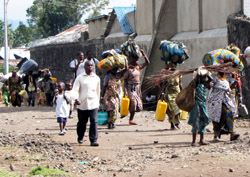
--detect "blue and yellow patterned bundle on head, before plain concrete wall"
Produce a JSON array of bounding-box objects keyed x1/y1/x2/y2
[{"x1": 160, "y1": 40, "x2": 189, "y2": 64}]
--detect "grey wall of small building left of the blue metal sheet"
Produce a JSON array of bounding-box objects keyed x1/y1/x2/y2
[{"x1": 88, "y1": 17, "x2": 108, "y2": 39}]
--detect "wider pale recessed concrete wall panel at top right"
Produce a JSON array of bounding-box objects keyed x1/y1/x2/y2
[{"x1": 202, "y1": 0, "x2": 241, "y2": 30}]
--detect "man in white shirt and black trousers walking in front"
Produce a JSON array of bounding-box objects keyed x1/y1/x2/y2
[{"x1": 73, "y1": 61, "x2": 100, "y2": 146}]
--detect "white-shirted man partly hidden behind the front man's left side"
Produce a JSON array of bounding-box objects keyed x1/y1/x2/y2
[{"x1": 69, "y1": 52, "x2": 85, "y2": 78}]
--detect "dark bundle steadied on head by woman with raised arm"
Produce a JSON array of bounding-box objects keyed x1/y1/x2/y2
[{"x1": 121, "y1": 40, "x2": 142, "y2": 60}]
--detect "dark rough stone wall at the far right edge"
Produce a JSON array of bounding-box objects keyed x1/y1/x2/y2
[{"x1": 228, "y1": 15, "x2": 250, "y2": 110}]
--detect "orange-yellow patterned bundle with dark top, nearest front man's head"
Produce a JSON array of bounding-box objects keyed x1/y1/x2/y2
[{"x1": 97, "y1": 50, "x2": 127, "y2": 71}]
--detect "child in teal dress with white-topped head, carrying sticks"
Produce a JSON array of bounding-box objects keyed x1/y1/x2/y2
[{"x1": 188, "y1": 68, "x2": 212, "y2": 146}]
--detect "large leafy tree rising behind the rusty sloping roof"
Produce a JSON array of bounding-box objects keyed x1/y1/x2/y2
[{"x1": 27, "y1": 0, "x2": 109, "y2": 39}]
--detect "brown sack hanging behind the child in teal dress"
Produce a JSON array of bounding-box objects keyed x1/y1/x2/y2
[{"x1": 175, "y1": 79, "x2": 195, "y2": 112}]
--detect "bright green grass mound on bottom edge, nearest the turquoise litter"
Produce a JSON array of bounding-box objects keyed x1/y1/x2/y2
[{"x1": 28, "y1": 166, "x2": 70, "y2": 177}]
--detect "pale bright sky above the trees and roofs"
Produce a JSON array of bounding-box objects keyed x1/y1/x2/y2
[{"x1": 0, "y1": 0, "x2": 136, "y2": 21}]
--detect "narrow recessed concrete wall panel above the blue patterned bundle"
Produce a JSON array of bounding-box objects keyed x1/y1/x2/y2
[{"x1": 177, "y1": 0, "x2": 199, "y2": 32}]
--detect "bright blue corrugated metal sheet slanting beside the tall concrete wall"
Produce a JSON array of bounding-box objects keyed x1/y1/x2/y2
[{"x1": 114, "y1": 7, "x2": 136, "y2": 34}]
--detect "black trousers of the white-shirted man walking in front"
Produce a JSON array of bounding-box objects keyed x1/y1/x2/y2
[{"x1": 76, "y1": 108, "x2": 98, "y2": 143}]
